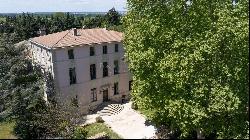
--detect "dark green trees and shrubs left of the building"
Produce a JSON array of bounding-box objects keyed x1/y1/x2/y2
[{"x1": 0, "y1": 35, "x2": 86, "y2": 139}]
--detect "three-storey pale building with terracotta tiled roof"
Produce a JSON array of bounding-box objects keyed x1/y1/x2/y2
[{"x1": 30, "y1": 28, "x2": 132, "y2": 112}]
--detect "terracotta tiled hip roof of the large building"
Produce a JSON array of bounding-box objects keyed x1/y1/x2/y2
[{"x1": 31, "y1": 28, "x2": 122, "y2": 48}]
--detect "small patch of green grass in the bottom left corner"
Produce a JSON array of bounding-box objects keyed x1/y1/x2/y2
[{"x1": 0, "y1": 122, "x2": 16, "y2": 139}]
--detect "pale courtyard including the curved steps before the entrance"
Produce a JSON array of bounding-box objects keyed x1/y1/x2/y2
[{"x1": 83, "y1": 102, "x2": 156, "y2": 139}]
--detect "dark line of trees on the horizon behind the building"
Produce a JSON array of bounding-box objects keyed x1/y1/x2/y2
[{"x1": 0, "y1": 8, "x2": 122, "y2": 42}]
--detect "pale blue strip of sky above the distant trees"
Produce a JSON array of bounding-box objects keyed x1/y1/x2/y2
[{"x1": 0, "y1": 0, "x2": 126, "y2": 13}]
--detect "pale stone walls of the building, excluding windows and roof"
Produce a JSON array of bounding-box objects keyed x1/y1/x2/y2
[{"x1": 31, "y1": 43, "x2": 132, "y2": 112}]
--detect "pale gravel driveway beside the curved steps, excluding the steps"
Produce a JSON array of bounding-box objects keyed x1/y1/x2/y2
[{"x1": 102, "y1": 102, "x2": 156, "y2": 139}]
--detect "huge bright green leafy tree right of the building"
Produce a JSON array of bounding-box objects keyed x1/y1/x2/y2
[{"x1": 123, "y1": 0, "x2": 249, "y2": 138}]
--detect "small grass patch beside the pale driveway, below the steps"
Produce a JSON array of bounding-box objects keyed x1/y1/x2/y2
[{"x1": 84, "y1": 123, "x2": 121, "y2": 139}]
